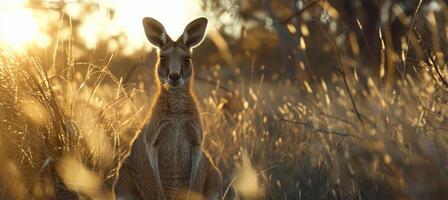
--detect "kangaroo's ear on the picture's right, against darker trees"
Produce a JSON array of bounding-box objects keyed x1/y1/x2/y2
[{"x1": 179, "y1": 17, "x2": 208, "y2": 48}]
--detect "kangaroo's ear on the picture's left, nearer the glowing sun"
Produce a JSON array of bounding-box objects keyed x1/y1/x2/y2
[{"x1": 143, "y1": 17, "x2": 171, "y2": 48}]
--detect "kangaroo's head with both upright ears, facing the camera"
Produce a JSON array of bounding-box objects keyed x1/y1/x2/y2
[{"x1": 143, "y1": 17, "x2": 207, "y2": 87}]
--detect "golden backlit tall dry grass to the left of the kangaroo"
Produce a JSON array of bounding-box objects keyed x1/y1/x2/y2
[{"x1": 0, "y1": 47, "x2": 142, "y2": 199}]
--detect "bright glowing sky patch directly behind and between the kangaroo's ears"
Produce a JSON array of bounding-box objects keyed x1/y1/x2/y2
[{"x1": 79, "y1": 0, "x2": 200, "y2": 54}]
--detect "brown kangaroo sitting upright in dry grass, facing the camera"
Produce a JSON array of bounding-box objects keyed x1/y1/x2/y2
[{"x1": 114, "y1": 17, "x2": 222, "y2": 200}]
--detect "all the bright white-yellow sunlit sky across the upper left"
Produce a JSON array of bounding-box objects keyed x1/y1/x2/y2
[{"x1": 0, "y1": 0, "x2": 201, "y2": 54}]
